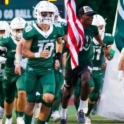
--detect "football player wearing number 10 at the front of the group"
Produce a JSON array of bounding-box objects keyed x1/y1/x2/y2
[{"x1": 21, "y1": 1, "x2": 64, "y2": 124}]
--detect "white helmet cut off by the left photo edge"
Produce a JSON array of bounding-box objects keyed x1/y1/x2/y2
[{"x1": 0, "y1": 21, "x2": 10, "y2": 36}]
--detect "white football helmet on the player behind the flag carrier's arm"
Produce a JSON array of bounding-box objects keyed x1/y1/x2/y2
[{"x1": 92, "y1": 14, "x2": 106, "y2": 36}]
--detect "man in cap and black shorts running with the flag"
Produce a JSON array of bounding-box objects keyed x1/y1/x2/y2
[{"x1": 60, "y1": 6, "x2": 110, "y2": 124}]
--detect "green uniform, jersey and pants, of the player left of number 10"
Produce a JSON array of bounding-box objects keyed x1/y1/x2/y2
[{"x1": 0, "y1": 35, "x2": 25, "y2": 103}]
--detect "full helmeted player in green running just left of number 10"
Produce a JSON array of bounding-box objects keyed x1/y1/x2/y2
[{"x1": 0, "y1": 17, "x2": 26, "y2": 124}]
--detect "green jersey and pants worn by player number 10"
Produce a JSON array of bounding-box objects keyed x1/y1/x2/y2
[{"x1": 23, "y1": 24, "x2": 64, "y2": 102}]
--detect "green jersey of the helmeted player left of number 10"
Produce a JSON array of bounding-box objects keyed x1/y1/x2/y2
[{"x1": 0, "y1": 35, "x2": 18, "y2": 70}]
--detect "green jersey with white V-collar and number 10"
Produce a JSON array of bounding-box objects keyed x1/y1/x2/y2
[{"x1": 23, "y1": 23, "x2": 64, "y2": 68}]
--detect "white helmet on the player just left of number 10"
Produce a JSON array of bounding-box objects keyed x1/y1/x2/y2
[{"x1": 10, "y1": 17, "x2": 26, "y2": 41}]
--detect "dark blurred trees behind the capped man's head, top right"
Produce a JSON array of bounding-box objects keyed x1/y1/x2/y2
[{"x1": 76, "y1": 0, "x2": 118, "y2": 33}]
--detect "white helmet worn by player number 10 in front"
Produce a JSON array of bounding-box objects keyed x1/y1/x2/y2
[{"x1": 34, "y1": 1, "x2": 55, "y2": 25}]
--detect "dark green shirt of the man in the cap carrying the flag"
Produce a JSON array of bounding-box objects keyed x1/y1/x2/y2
[{"x1": 66, "y1": 25, "x2": 98, "y2": 69}]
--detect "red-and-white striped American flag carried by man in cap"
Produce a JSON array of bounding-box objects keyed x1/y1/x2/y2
[{"x1": 64, "y1": 0, "x2": 84, "y2": 69}]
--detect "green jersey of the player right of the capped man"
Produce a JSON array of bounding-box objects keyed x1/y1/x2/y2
[{"x1": 93, "y1": 33, "x2": 114, "y2": 68}]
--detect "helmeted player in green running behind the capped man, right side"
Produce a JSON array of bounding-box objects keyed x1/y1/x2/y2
[{"x1": 85, "y1": 15, "x2": 114, "y2": 124}]
